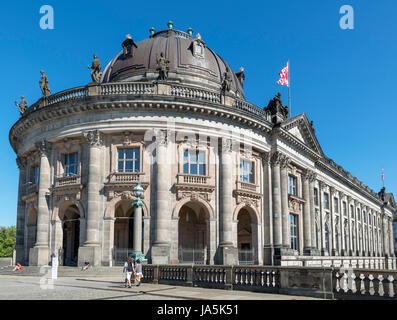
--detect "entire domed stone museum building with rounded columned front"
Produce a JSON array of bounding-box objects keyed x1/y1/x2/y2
[{"x1": 9, "y1": 22, "x2": 397, "y2": 269}]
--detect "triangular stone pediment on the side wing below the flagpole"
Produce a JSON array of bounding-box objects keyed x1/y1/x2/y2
[{"x1": 281, "y1": 113, "x2": 324, "y2": 156}]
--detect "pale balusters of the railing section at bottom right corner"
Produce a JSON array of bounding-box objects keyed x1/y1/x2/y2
[{"x1": 332, "y1": 268, "x2": 397, "y2": 299}]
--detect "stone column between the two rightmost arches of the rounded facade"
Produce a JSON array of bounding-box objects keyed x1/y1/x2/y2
[{"x1": 215, "y1": 139, "x2": 238, "y2": 265}]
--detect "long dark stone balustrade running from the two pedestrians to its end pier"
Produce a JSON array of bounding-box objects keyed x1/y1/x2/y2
[{"x1": 143, "y1": 265, "x2": 333, "y2": 299}]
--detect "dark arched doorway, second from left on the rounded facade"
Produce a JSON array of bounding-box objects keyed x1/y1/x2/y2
[{"x1": 61, "y1": 205, "x2": 80, "y2": 266}]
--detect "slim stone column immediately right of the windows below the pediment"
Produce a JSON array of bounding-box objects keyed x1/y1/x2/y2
[{"x1": 302, "y1": 170, "x2": 312, "y2": 255}]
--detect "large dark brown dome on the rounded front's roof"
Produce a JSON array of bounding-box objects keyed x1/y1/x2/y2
[{"x1": 101, "y1": 29, "x2": 245, "y2": 99}]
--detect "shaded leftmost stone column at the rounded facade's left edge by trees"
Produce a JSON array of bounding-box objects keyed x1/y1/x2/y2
[{"x1": 15, "y1": 157, "x2": 28, "y2": 264}]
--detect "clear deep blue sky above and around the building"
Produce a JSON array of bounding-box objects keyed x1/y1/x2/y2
[{"x1": 0, "y1": 0, "x2": 397, "y2": 226}]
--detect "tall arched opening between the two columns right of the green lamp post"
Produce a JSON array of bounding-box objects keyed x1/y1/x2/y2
[{"x1": 178, "y1": 201, "x2": 208, "y2": 264}]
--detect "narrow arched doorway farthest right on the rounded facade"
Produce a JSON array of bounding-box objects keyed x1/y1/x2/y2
[{"x1": 237, "y1": 208, "x2": 255, "y2": 264}]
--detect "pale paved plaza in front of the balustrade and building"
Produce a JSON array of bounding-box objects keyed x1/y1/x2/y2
[{"x1": 0, "y1": 275, "x2": 317, "y2": 300}]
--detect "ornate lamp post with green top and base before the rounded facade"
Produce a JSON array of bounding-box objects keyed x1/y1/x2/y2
[{"x1": 131, "y1": 181, "x2": 147, "y2": 262}]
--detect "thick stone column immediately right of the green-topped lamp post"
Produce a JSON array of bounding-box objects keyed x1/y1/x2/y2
[{"x1": 151, "y1": 131, "x2": 171, "y2": 264}]
